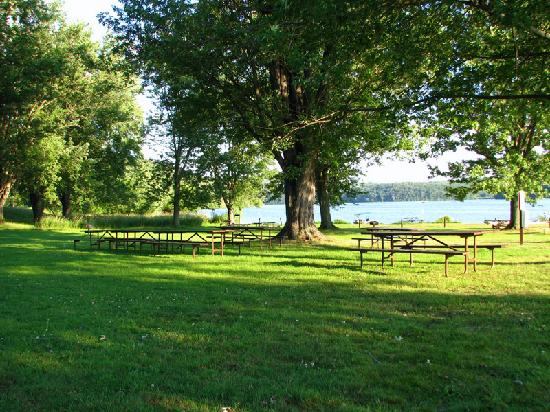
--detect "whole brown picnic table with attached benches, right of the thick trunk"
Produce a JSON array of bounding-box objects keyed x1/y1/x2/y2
[{"x1": 354, "y1": 228, "x2": 500, "y2": 275}]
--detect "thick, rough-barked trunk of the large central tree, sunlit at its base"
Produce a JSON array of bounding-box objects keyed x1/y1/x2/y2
[{"x1": 281, "y1": 158, "x2": 323, "y2": 240}]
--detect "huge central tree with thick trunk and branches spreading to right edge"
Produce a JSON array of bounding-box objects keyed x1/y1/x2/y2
[{"x1": 105, "y1": 0, "x2": 548, "y2": 238}]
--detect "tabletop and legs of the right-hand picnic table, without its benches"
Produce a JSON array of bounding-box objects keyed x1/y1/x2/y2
[{"x1": 365, "y1": 229, "x2": 485, "y2": 273}]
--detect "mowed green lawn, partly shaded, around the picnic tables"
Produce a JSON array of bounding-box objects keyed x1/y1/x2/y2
[{"x1": 0, "y1": 224, "x2": 550, "y2": 411}]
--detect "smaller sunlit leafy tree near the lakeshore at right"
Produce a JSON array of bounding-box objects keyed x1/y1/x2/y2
[{"x1": 433, "y1": 102, "x2": 550, "y2": 227}]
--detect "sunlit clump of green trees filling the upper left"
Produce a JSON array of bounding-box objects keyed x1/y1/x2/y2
[{"x1": 0, "y1": 0, "x2": 147, "y2": 221}]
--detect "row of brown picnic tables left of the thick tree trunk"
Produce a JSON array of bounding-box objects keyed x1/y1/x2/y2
[{"x1": 84, "y1": 224, "x2": 282, "y2": 256}]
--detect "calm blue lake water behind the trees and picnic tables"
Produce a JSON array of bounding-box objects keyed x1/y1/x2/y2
[{"x1": 202, "y1": 199, "x2": 550, "y2": 223}]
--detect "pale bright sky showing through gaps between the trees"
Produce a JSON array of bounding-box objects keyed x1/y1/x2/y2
[{"x1": 49, "y1": 0, "x2": 469, "y2": 183}]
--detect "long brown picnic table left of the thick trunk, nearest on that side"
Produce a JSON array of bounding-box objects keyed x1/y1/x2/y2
[{"x1": 84, "y1": 229, "x2": 232, "y2": 256}]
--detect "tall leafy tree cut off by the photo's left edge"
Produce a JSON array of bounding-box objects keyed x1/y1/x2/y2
[{"x1": 0, "y1": 0, "x2": 62, "y2": 223}]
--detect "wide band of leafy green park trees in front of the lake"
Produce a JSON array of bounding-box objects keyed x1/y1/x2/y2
[{"x1": 0, "y1": 0, "x2": 550, "y2": 235}]
